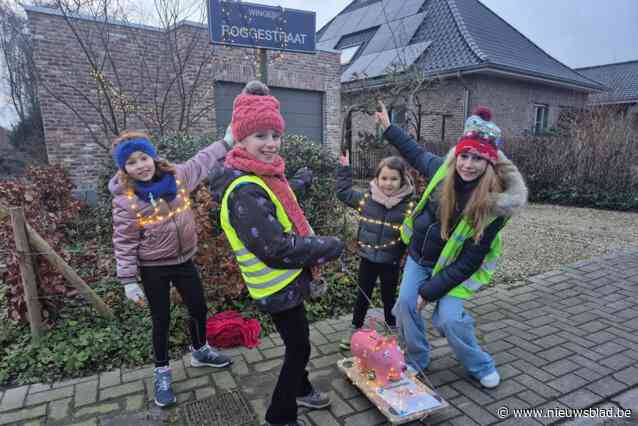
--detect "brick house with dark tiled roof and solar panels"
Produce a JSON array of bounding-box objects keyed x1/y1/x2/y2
[{"x1": 318, "y1": 0, "x2": 604, "y2": 152}]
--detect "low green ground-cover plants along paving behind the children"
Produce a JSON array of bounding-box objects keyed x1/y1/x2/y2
[{"x1": 0, "y1": 243, "x2": 372, "y2": 386}]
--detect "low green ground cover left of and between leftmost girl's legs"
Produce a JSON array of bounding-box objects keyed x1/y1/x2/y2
[{"x1": 0, "y1": 279, "x2": 190, "y2": 385}]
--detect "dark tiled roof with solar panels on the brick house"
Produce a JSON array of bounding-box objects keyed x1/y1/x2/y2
[{"x1": 318, "y1": 0, "x2": 603, "y2": 90}]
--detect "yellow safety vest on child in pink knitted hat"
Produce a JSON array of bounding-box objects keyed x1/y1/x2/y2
[{"x1": 220, "y1": 175, "x2": 302, "y2": 299}]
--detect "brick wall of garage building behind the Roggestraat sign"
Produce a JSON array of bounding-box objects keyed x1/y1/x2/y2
[{"x1": 27, "y1": 9, "x2": 341, "y2": 197}]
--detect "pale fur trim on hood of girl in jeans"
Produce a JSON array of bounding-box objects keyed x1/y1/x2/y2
[{"x1": 445, "y1": 148, "x2": 528, "y2": 217}]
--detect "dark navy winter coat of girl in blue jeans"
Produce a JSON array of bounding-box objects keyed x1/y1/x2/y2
[{"x1": 384, "y1": 125, "x2": 527, "y2": 301}]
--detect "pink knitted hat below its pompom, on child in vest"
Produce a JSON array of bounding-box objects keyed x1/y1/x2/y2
[{"x1": 232, "y1": 93, "x2": 285, "y2": 141}]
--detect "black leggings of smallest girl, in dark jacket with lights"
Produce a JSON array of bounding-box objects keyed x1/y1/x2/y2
[{"x1": 352, "y1": 258, "x2": 399, "y2": 328}]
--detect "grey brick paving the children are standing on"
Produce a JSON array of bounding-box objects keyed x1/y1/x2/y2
[{"x1": 0, "y1": 250, "x2": 638, "y2": 426}]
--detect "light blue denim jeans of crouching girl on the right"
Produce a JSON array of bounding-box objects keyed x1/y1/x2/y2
[{"x1": 393, "y1": 256, "x2": 496, "y2": 379}]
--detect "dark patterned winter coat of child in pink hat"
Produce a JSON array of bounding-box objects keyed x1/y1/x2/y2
[{"x1": 209, "y1": 168, "x2": 344, "y2": 312}]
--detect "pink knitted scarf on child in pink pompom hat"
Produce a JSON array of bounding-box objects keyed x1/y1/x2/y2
[{"x1": 224, "y1": 147, "x2": 312, "y2": 237}]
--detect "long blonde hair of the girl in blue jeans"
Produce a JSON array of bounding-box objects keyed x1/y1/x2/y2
[{"x1": 439, "y1": 156, "x2": 503, "y2": 243}]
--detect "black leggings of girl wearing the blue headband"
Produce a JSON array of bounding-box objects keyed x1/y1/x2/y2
[{"x1": 140, "y1": 260, "x2": 208, "y2": 367}]
